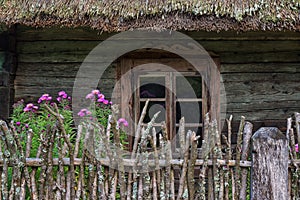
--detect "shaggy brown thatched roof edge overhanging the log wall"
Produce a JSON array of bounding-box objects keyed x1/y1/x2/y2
[{"x1": 0, "y1": 0, "x2": 300, "y2": 32}]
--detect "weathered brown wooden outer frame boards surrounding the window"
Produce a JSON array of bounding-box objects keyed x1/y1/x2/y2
[{"x1": 120, "y1": 58, "x2": 220, "y2": 147}]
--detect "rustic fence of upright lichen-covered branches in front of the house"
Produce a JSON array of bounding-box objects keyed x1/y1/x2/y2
[{"x1": 0, "y1": 103, "x2": 300, "y2": 200}]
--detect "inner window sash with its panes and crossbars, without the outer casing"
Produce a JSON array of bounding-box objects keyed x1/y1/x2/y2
[{"x1": 134, "y1": 71, "x2": 203, "y2": 147}]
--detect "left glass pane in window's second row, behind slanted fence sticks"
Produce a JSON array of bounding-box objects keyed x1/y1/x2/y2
[{"x1": 140, "y1": 101, "x2": 166, "y2": 123}]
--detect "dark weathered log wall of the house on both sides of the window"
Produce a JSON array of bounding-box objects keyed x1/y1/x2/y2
[{"x1": 14, "y1": 27, "x2": 300, "y2": 132}]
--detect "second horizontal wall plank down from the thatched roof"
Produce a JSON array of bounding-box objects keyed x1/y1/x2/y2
[{"x1": 17, "y1": 39, "x2": 300, "y2": 54}]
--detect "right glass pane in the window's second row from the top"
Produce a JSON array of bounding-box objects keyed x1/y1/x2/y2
[{"x1": 176, "y1": 102, "x2": 202, "y2": 123}]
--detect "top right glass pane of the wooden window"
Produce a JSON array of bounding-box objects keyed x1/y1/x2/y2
[{"x1": 176, "y1": 76, "x2": 202, "y2": 98}]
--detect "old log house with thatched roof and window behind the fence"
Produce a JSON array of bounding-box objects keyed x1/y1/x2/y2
[{"x1": 0, "y1": 0, "x2": 300, "y2": 139}]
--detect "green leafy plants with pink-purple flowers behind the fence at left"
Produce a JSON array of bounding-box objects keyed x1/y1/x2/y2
[{"x1": 11, "y1": 90, "x2": 128, "y2": 157}]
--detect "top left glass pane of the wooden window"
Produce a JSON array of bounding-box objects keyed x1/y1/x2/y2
[{"x1": 140, "y1": 76, "x2": 166, "y2": 98}]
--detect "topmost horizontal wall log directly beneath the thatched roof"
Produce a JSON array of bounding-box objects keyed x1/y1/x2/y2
[{"x1": 16, "y1": 26, "x2": 299, "y2": 41}]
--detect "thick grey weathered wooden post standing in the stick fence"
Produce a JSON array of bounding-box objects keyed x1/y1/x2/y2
[{"x1": 251, "y1": 127, "x2": 289, "y2": 200}]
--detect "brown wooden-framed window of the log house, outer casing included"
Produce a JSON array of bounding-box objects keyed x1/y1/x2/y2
[{"x1": 121, "y1": 58, "x2": 219, "y2": 147}]
